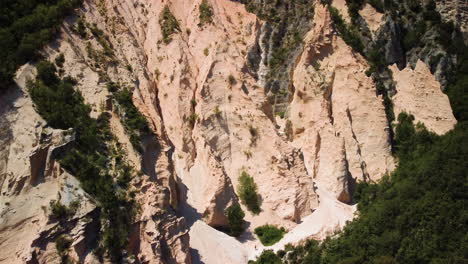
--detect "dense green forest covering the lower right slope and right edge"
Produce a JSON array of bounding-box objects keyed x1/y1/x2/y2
[{"x1": 252, "y1": 0, "x2": 468, "y2": 264}]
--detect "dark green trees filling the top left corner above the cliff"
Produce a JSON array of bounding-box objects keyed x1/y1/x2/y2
[{"x1": 0, "y1": 0, "x2": 82, "y2": 90}]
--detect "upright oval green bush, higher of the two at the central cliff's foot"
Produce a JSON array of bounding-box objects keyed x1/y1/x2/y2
[{"x1": 237, "y1": 171, "x2": 261, "y2": 214}]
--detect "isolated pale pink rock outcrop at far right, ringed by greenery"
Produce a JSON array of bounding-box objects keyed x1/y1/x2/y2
[{"x1": 389, "y1": 61, "x2": 457, "y2": 135}]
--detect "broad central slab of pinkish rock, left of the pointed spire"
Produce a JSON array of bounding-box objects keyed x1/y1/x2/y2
[{"x1": 152, "y1": 1, "x2": 317, "y2": 230}]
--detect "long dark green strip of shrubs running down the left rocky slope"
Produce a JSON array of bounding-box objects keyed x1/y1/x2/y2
[{"x1": 28, "y1": 61, "x2": 136, "y2": 262}]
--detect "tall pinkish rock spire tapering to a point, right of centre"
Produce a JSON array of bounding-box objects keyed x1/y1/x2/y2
[{"x1": 289, "y1": 5, "x2": 394, "y2": 202}]
